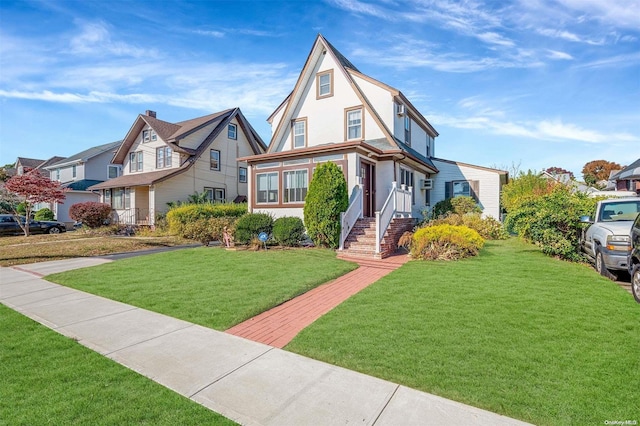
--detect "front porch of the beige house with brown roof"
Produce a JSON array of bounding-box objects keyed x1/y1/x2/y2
[{"x1": 104, "y1": 186, "x2": 155, "y2": 226}]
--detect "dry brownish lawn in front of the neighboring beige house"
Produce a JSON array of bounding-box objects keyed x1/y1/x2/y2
[{"x1": 0, "y1": 231, "x2": 193, "y2": 266}]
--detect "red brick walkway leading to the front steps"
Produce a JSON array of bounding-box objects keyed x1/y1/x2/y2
[{"x1": 226, "y1": 254, "x2": 409, "y2": 348}]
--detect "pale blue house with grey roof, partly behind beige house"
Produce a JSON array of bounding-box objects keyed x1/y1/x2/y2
[{"x1": 44, "y1": 141, "x2": 122, "y2": 224}]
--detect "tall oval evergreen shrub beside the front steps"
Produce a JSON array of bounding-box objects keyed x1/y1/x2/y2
[{"x1": 304, "y1": 161, "x2": 349, "y2": 248}]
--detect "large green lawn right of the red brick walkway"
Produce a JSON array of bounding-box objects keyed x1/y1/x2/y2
[{"x1": 286, "y1": 240, "x2": 640, "y2": 425}]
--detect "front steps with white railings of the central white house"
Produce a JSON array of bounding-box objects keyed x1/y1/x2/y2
[{"x1": 339, "y1": 178, "x2": 416, "y2": 259}]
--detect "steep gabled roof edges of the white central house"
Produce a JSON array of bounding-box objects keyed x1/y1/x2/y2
[{"x1": 267, "y1": 34, "x2": 438, "y2": 161}]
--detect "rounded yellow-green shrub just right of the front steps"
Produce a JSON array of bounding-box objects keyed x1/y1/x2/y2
[{"x1": 411, "y1": 224, "x2": 484, "y2": 260}]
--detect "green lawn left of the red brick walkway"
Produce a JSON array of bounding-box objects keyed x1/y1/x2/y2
[{"x1": 47, "y1": 247, "x2": 357, "y2": 330}]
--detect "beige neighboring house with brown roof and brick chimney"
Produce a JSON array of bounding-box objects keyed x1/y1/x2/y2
[{"x1": 89, "y1": 108, "x2": 266, "y2": 225}]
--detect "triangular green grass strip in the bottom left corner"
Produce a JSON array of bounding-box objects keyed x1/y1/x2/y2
[{"x1": 0, "y1": 305, "x2": 235, "y2": 426}]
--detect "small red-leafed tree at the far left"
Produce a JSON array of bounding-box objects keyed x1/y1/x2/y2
[{"x1": 4, "y1": 170, "x2": 66, "y2": 237}]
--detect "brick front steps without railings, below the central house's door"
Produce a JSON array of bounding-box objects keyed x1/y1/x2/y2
[{"x1": 339, "y1": 217, "x2": 416, "y2": 259}]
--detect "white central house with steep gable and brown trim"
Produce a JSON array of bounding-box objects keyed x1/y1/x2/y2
[{"x1": 241, "y1": 35, "x2": 508, "y2": 257}]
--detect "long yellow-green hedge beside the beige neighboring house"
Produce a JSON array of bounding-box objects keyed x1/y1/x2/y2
[{"x1": 166, "y1": 203, "x2": 247, "y2": 235}]
